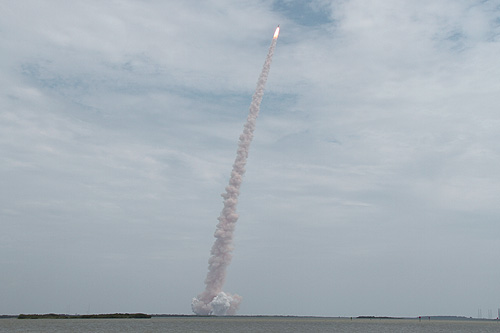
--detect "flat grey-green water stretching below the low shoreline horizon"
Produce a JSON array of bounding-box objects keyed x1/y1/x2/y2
[{"x1": 0, "y1": 317, "x2": 500, "y2": 333}]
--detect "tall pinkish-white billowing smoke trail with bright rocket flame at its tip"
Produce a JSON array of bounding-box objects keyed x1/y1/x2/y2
[{"x1": 191, "y1": 26, "x2": 280, "y2": 316}]
